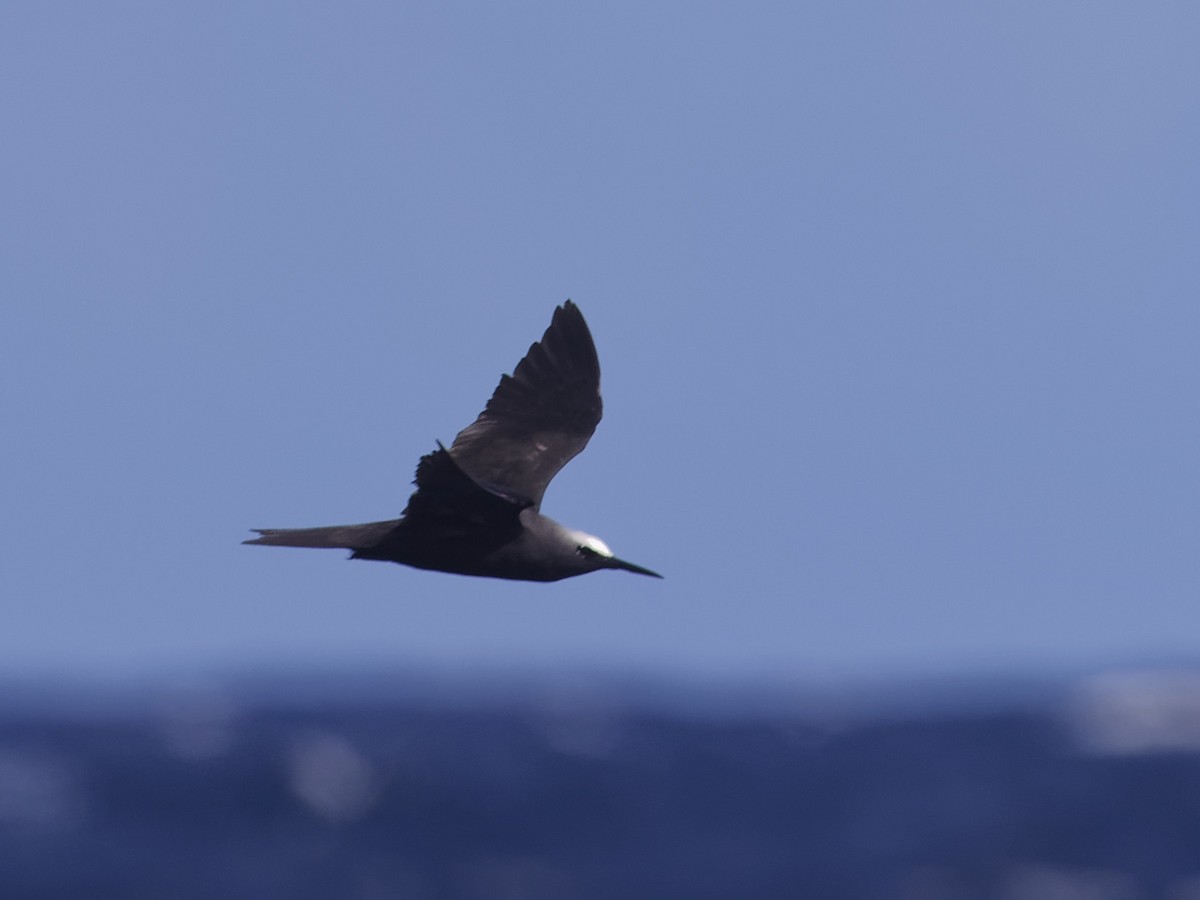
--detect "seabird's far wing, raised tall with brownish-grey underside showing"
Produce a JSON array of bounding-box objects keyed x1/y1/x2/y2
[{"x1": 450, "y1": 300, "x2": 602, "y2": 509}]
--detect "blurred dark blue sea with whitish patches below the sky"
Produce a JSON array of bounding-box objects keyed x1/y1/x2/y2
[{"x1": 0, "y1": 676, "x2": 1200, "y2": 900}]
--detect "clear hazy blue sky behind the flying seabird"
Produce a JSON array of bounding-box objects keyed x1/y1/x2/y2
[{"x1": 0, "y1": 1, "x2": 1200, "y2": 678}]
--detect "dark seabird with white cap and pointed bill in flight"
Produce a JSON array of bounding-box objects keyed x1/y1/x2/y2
[{"x1": 242, "y1": 300, "x2": 662, "y2": 582}]
